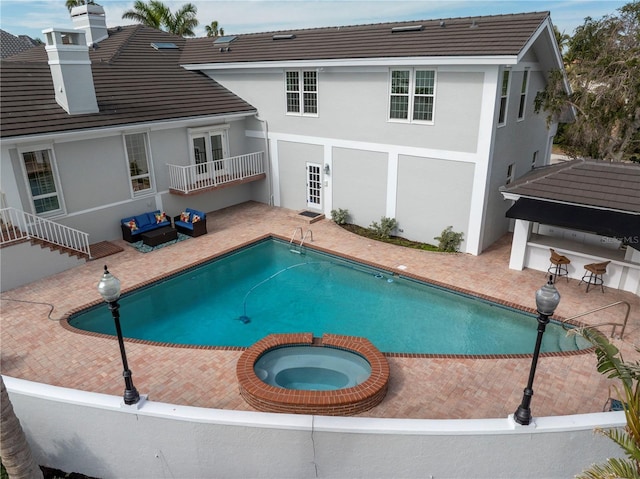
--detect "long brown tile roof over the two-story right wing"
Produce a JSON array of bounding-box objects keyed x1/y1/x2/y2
[{"x1": 180, "y1": 11, "x2": 549, "y2": 65}]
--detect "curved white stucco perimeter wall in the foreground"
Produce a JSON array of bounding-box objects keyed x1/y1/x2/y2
[{"x1": 3, "y1": 376, "x2": 625, "y2": 479}]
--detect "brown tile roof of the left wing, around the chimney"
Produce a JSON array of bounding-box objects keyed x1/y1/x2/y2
[{"x1": 0, "y1": 25, "x2": 256, "y2": 138}]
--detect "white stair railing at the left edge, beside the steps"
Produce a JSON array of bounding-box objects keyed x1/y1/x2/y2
[{"x1": 0, "y1": 208, "x2": 91, "y2": 258}]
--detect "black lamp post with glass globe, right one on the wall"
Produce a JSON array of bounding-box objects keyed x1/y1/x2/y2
[{"x1": 513, "y1": 276, "x2": 560, "y2": 426}]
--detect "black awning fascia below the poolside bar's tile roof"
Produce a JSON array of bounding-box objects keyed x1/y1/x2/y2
[{"x1": 506, "y1": 198, "x2": 640, "y2": 249}]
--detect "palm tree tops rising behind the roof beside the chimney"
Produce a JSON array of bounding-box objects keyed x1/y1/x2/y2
[{"x1": 122, "y1": 0, "x2": 198, "y2": 37}]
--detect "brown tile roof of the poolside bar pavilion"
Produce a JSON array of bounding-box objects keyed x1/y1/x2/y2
[{"x1": 502, "y1": 160, "x2": 640, "y2": 213}]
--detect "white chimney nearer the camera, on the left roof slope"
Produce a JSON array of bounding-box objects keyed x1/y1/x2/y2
[{"x1": 42, "y1": 28, "x2": 100, "y2": 115}]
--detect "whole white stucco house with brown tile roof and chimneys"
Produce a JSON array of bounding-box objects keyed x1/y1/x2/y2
[{"x1": 0, "y1": 5, "x2": 562, "y2": 289}]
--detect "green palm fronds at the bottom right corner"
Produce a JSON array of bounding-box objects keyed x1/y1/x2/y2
[{"x1": 576, "y1": 327, "x2": 640, "y2": 479}]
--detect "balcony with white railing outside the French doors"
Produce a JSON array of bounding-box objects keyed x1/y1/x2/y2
[{"x1": 167, "y1": 151, "x2": 266, "y2": 195}]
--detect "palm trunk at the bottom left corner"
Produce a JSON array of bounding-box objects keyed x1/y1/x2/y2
[{"x1": 0, "y1": 376, "x2": 43, "y2": 478}]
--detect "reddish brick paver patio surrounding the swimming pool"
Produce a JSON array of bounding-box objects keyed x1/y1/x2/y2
[{"x1": 0, "y1": 202, "x2": 640, "y2": 418}]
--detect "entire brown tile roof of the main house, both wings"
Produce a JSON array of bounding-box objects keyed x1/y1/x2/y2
[{"x1": 0, "y1": 12, "x2": 549, "y2": 138}]
